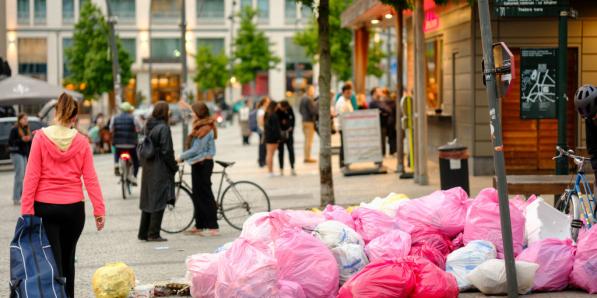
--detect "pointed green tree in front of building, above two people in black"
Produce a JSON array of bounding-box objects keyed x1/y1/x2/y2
[{"x1": 234, "y1": 7, "x2": 280, "y2": 95}]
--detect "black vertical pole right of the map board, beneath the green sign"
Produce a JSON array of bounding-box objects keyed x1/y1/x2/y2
[{"x1": 556, "y1": 9, "x2": 568, "y2": 175}]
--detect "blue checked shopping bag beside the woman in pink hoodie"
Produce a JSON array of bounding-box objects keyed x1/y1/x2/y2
[{"x1": 10, "y1": 215, "x2": 66, "y2": 298}]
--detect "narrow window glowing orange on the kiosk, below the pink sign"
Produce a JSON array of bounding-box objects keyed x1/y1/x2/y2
[{"x1": 425, "y1": 39, "x2": 443, "y2": 114}]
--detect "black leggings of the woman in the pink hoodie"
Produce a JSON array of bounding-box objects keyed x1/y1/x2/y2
[{"x1": 34, "y1": 202, "x2": 85, "y2": 298}]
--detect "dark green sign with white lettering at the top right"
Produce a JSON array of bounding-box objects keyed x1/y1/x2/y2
[{"x1": 494, "y1": 0, "x2": 568, "y2": 17}]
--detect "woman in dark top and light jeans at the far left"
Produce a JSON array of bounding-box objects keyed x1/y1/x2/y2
[{"x1": 8, "y1": 113, "x2": 33, "y2": 205}]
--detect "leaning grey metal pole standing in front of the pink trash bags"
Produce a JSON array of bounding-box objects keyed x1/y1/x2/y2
[{"x1": 478, "y1": 0, "x2": 518, "y2": 297}]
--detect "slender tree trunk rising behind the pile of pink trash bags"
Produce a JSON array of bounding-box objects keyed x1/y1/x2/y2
[{"x1": 317, "y1": 0, "x2": 334, "y2": 207}]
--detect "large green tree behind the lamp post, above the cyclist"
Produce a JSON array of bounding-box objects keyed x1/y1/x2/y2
[{"x1": 66, "y1": 1, "x2": 132, "y2": 98}]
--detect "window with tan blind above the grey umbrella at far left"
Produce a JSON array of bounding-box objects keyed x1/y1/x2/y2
[{"x1": 18, "y1": 38, "x2": 48, "y2": 81}]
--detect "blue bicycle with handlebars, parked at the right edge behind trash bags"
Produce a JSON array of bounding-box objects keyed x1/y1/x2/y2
[{"x1": 553, "y1": 146, "x2": 597, "y2": 241}]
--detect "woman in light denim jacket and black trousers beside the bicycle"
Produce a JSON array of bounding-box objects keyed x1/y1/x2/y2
[{"x1": 178, "y1": 102, "x2": 219, "y2": 236}]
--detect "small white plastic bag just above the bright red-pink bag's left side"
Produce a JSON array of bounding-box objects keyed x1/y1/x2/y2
[{"x1": 328, "y1": 244, "x2": 369, "y2": 284}]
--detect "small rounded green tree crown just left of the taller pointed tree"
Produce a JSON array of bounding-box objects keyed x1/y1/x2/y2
[{"x1": 194, "y1": 46, "x2": 229, "y2": 92}]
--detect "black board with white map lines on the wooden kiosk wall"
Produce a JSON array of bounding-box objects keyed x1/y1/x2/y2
[{"x1": 520, "y1": 48, "x2": 558, "y2": 119}]
